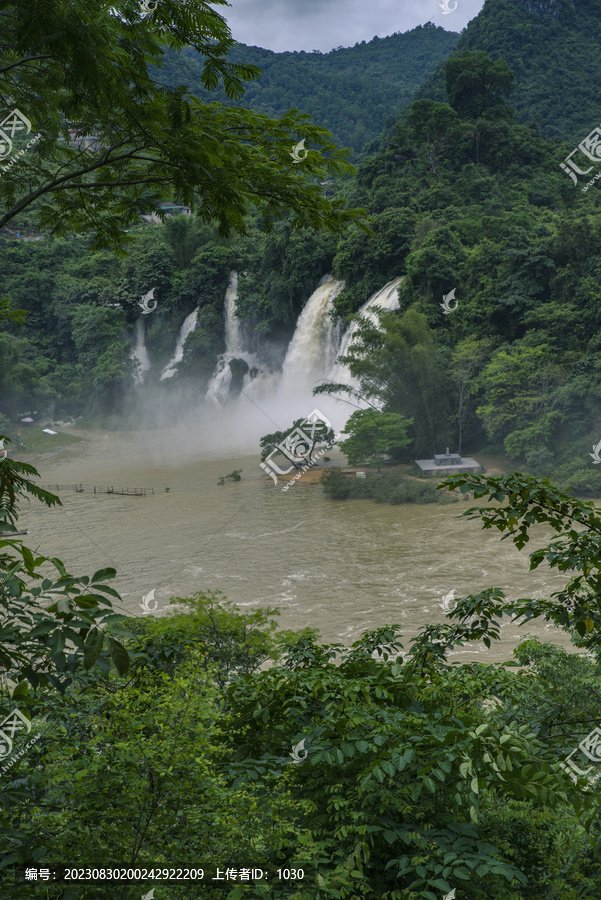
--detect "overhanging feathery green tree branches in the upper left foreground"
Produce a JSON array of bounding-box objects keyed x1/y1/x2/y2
[{"x1": 0, "y1": 0, "x2": 368, "y2": 247}]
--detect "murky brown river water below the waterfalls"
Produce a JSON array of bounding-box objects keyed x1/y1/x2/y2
[{"x1": 19, "y1": 431, "x2": 569, "y2": 662}]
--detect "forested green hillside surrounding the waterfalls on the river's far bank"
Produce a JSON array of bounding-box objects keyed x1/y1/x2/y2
[{"x1": 5, "y1": 0, "x2": 601, "y2": 495}]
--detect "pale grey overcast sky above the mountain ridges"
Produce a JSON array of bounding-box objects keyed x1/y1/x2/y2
[{"x1": 220, "y1": 0, "x2": 484, "y2": 53}]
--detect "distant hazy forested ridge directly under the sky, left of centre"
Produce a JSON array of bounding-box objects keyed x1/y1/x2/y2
[{"x1": 155, "y1": 22, "x2": 459, "y2": 152}]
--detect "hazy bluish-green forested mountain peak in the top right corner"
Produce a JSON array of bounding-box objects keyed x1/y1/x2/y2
[{"x1": 416, "y1": 0, "x2": 601, "y2": 144}]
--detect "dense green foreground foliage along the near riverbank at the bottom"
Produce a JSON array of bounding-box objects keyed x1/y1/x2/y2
[{"x1": 0, "y1": 475, "x2": 601, "y2": 900}]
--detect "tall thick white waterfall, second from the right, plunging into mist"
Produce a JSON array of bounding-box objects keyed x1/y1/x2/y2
[{"x1": 282, "y1": 275, "x2": 344, "y2": 391}]
